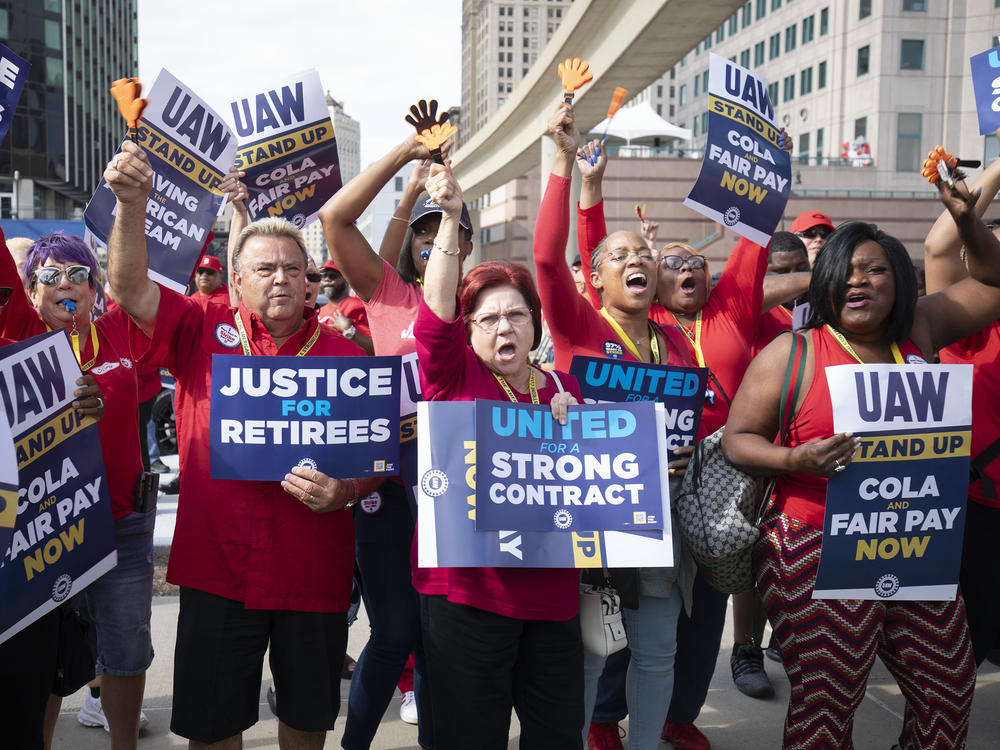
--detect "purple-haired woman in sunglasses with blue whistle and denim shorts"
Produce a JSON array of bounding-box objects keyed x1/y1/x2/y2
[{"x1": 0, "y1": 232, "x2": 156, "y2": 748}]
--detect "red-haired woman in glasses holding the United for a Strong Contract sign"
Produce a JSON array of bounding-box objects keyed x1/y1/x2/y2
[{"x1": 414, "y1": 167, "x2": 583, "y2": 750}]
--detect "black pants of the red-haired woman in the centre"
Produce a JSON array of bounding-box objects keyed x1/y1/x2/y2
[{"x1": 420, "y1": 596, "x2": 583, "y2": 750}]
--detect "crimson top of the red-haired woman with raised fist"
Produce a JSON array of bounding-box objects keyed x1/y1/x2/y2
[{"x1": 414, "y1": 303, "x2": 583, "y2": 620}]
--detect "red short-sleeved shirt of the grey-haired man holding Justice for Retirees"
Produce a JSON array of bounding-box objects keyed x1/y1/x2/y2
[{"x1": 130, "y1": 287, "x2": 364, "y2": 612}]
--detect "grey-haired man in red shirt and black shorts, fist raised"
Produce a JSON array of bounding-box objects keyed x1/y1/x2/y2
[{"x1": 104, "y1": 142, "x2": 379, "y2": 748}]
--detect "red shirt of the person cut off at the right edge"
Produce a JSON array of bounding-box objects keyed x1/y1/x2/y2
[{"x1": 938, "y1": 320, "x2": 1000, "y2": 508}]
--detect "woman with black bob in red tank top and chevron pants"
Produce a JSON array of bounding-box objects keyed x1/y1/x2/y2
[{"x1": 723, "y1": 183, "x2": 1000, "y2": 748}]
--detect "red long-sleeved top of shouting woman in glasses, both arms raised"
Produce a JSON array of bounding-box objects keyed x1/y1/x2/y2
[{"x1": 534, "y1": 174, "x2": 694, "y2": 371}]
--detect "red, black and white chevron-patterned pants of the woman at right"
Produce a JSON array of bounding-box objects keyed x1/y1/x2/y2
[{"x1": 754, "y1": 510, "x2": 976, "y2": 750}]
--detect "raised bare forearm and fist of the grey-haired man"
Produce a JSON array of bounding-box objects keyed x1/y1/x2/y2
[{"x1": 104, "y1": 141, "x2": 160, "y2": 336}]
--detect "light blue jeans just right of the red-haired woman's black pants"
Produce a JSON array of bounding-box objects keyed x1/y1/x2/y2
[{"x1": 583, "y1": 583, "x2": 683, "y2": 750}]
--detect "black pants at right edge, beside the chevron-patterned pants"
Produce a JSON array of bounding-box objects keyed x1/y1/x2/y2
[{"x1": 959, "y1": 499, "x2": 1000, "y2": 667}]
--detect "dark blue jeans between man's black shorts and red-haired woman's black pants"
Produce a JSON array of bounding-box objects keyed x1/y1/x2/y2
[{"x1": 341, "y1": 482, "x2": 433, "y2": 750}]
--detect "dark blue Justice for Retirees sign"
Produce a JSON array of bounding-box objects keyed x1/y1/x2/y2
[{"x1": 210, "y1": 354, "x2": 400, "y2": 481}]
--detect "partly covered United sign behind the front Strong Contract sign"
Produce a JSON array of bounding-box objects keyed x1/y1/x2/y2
[{"x1": 569, "y1": 355, "x2": 708, "y2": 455}]
